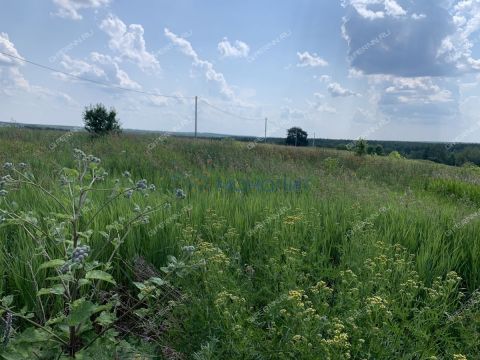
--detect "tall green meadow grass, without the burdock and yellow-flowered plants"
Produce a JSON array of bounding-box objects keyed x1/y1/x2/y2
[{"x1": 0, "y1": 129, "x2": 480, "y2": 359}]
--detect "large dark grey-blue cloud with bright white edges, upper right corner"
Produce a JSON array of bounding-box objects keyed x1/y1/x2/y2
[{"x1": 342, "y1": 0, "x2": 480, "y2": 77}]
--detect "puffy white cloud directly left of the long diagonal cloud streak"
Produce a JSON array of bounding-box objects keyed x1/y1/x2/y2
[{"x1": 100, "y1": 15, "x2": 160, "y2": 71}]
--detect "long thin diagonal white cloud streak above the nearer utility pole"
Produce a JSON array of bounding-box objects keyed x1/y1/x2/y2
[{"x1": 165, "y1": 29, "x2": 239, "y2": 102}]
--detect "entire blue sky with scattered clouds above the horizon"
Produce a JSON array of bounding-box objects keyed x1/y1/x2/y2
[{"x1": 0, "y1": 0, "x2": 480, "y2": 142}]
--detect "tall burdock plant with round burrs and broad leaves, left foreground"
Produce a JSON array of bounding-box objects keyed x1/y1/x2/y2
[{"x1": 0, "y1": 149, "x2": 169, "y2": 359}]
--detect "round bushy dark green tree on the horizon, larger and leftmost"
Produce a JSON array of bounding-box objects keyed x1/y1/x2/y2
[{"x1": 83, "y1": 104, "x2": 121, "y2": 135}]
